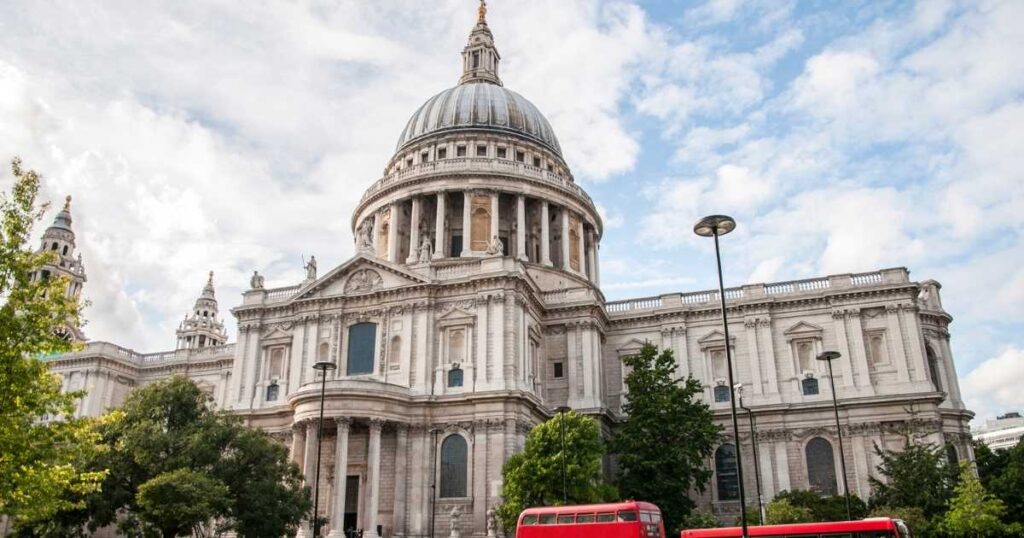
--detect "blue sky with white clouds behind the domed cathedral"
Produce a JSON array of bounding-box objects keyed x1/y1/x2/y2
[{"x1": 0, "y1": 0, "x2": 1024, "y2": 420}]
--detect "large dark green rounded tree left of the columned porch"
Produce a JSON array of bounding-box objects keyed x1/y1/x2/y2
[{"x1": 23, "y1": 376, "x2": 311, "y2": 536}]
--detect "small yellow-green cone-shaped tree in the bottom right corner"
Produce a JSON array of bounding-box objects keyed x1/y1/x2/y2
[{"x1": 940, "y1": 462, "x2": 1007, "y2": 538}]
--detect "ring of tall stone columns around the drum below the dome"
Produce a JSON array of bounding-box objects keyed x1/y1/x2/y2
[{"x1": 373, "y1": 190, "x2": 600, "y2": 285}]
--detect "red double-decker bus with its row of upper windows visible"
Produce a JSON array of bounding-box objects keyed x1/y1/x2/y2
[{"x1": 515, "y1": 501, "x2": 665, "y2": 538}]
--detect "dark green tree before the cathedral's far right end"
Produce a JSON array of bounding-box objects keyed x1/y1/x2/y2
[{"x1": 868, "y1": 438, "x2": 957, "y2": 519}]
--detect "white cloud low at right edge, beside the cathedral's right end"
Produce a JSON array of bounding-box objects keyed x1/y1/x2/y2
[{"x1": 961, "y1": 346, "x2": 1024, "y2": 422}]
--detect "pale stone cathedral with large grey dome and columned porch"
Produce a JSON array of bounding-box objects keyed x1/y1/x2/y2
[{"x1": 39, "y1": 6, "x2": 971, "y2": 537}]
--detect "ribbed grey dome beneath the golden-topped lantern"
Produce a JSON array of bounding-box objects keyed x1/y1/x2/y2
[{"x1": 397, "y1": 82, "x2": 562, "y2": 156}]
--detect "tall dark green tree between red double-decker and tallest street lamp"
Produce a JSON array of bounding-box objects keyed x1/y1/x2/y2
[{"x1": 611, "y1": 342, "x2": 721, "y2": 534}]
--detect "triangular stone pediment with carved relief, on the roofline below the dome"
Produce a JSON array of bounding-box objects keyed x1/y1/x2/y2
[{"x1": 295, "y1": 253, "x2": 430, "y2": 300}]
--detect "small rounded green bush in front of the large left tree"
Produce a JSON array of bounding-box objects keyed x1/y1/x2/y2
[{"x1": 136, "y1": 468, "x2": 228, "y2": 538}]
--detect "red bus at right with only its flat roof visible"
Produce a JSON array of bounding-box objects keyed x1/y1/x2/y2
[{"x1": 680, "y1": 518, "x2": 911, "y2": 538}]
